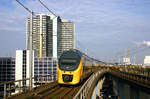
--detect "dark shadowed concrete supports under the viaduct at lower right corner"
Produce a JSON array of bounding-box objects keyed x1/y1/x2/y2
[{"x1": 112, "y1": 78, "x2": 150, "y2": 99}]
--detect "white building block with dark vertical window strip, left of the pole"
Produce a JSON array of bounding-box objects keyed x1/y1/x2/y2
[{"x1": 15, "y1": 50, "x2": 34, "y2": 89}]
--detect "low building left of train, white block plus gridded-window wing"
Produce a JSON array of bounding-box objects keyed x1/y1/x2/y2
[{"x1": 15, "y1": 50, "x2": 57, "y2": 86}]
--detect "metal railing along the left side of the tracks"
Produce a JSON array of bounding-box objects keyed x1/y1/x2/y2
[{"x1": 0, "y1": 74, "x2": 56, "y2": 98}]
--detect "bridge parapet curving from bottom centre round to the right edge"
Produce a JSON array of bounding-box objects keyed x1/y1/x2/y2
[{"x1": 74, "y1": 66, "x2": 150, "y2": 99}]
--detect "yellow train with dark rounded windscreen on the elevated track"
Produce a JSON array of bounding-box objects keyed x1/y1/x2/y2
[{"x1": 57, "y1": 49, "x2": 105, "y2": 85}]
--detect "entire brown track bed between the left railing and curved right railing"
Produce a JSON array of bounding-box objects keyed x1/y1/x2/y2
[{"x1": 8, "y1": 74, "x2": 91, "y2": 99}]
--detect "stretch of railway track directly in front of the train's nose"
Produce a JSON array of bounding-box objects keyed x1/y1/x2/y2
[{"x1": 33, "y1": 84, "x2": 82, "y2": 99}]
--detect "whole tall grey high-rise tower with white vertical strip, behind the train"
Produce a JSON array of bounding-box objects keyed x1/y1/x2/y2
[{"x1": 27, "y1": 14, "x2": 74, "y2": 58}]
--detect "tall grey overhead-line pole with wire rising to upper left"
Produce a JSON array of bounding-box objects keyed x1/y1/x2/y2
[{"x1": 16, "y1": 0, "x2": 34, "y2": 90}]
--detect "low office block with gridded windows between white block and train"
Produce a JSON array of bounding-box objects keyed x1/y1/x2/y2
[{"x1": 34, "y1": 57, "x2": 57, "y2": 84}]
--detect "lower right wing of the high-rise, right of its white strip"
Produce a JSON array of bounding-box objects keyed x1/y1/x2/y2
[{"x1": 58, "y1": 19, "x2": 74, "y2": 56}]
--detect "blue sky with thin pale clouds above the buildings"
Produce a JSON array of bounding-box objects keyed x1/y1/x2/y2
[{"x1": 0, "y1": 0, "x2": 150, "y2": 63}]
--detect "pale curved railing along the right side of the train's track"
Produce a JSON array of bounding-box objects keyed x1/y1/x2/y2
[{"x1": 73, "y1": 69, "x2": 109, "y2": 99}]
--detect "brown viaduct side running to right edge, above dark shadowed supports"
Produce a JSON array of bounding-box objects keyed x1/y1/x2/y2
[{"x1": 109, "y1": 68, "x2": 150, "y2": 88}]
